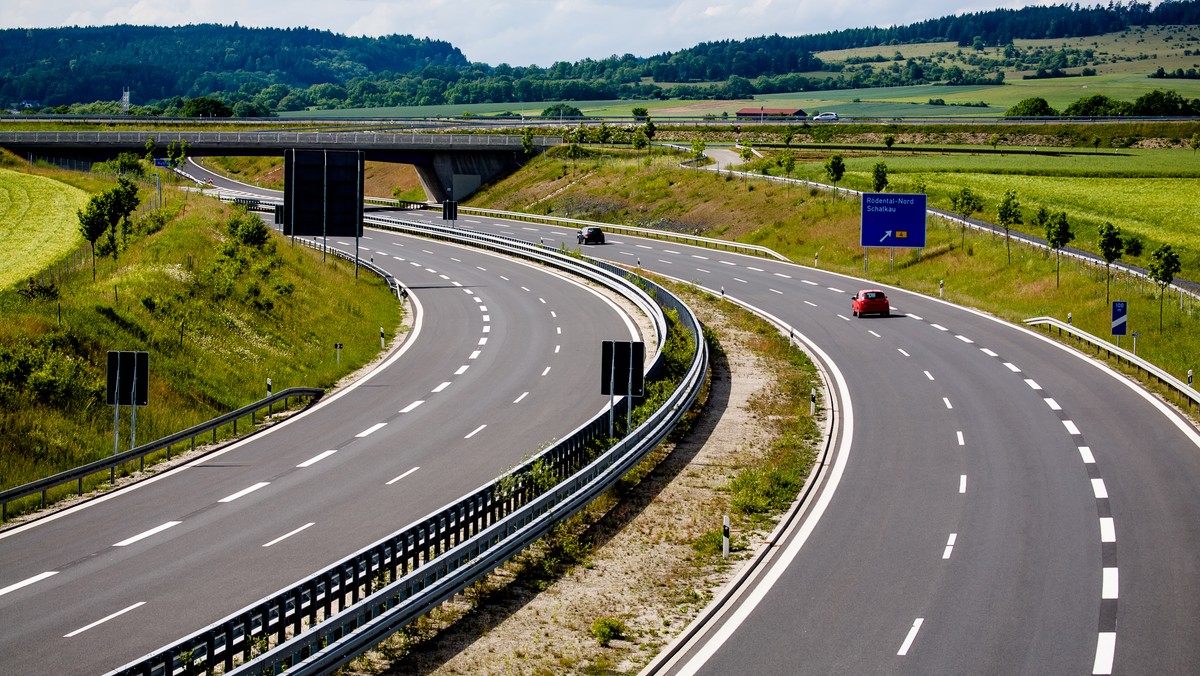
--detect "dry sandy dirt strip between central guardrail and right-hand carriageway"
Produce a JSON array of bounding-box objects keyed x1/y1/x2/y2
[{"x1": 343, "y1": 289, "x2": 801, "y2": 675}]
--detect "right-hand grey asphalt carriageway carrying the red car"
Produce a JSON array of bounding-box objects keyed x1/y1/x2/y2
[{"x1": 404, "y1": 207, "x2": 1200, "y2": 674}]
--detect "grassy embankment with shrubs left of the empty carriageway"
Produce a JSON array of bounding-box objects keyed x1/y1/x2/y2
[{"x1": 0, "y1": 159, "x2": 402, "y2": 513}]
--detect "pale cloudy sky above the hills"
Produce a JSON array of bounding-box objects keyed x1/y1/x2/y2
[{"x1": 0, "y1": 0, "x2": 1056, "y2": 66}]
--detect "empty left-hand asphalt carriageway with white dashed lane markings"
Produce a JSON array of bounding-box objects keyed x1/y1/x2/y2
[{"x1": 0, "y1": 189, "x2": 637, "y2": 674}]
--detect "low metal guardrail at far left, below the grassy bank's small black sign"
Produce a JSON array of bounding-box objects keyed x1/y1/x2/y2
[{"x1": 0, "y1": 388, "x2": 325, "y2": 522}]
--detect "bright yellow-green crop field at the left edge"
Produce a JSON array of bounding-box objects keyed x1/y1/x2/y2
[{"x1": 0, "y1": 169, "x2": 88, "y2": 289}]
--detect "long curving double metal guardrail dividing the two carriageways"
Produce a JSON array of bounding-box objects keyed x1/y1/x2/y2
[{"x1": 110, "y1": 219, "x2": 708, "y2": 675}]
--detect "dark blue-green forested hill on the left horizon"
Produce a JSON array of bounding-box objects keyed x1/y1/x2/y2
[{"x1": 0, "y1": 24, "x2": 468, "y2": 106}]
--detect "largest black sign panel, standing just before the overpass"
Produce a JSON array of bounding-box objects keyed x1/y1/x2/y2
[{"x1": 282, "y1": 150, "x2": 364, "y2": 237}]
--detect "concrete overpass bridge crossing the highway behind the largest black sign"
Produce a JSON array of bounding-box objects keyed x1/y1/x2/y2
[{"x1": 0, "y1": 131, "x2": 562, "y2": 202}]
